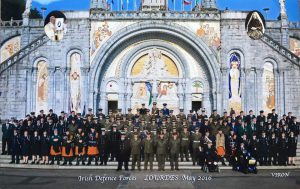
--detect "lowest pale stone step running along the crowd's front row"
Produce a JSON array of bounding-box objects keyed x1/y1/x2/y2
[{"x1": 0, "y1": 163, "x2": 300, "y2": 170}]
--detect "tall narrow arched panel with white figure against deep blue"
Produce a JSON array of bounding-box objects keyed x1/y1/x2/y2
[{"x1": 228, "y1": 53, "x2": 242, "y2": 112}]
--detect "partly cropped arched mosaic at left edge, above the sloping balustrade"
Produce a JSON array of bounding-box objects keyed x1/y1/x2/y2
[{"x1": 0, "y1": 36, "x2": 21, "y2": 63}]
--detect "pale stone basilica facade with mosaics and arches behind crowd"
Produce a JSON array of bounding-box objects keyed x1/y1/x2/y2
[{"x1": 0, "y1": 1, "x2": 300, "y2": 118}]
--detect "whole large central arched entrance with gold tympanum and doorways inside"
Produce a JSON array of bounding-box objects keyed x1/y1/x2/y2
[{"x1": 89, "y1": 21, "x2": 220, "y2": 113}]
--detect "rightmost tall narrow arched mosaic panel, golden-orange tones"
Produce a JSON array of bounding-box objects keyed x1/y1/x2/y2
[{"x1": 263, "y1": 62, "x2": 275, "y2": 113}]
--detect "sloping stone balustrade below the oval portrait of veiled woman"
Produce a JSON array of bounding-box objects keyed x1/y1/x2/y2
[{"x1": 261, "y1": 34, "x2": 300, "y2": 67}]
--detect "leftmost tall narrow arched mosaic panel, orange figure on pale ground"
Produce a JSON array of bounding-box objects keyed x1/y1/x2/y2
[{"x1": 36, "y1": 60, "x2": 49, "y2": 112}]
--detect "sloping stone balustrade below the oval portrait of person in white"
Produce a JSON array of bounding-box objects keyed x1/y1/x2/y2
[{"x1": 0, "y1": 34, "x2": 50, "y2": 75}]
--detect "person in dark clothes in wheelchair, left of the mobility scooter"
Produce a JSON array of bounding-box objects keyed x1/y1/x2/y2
[{"x1": 204, "y1": 141, "x2": 219, "y2": 172}]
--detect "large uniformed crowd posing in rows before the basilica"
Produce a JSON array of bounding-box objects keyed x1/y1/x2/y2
[{"x1": 2, "y1": 102, "x2": 299, "y2": 170}]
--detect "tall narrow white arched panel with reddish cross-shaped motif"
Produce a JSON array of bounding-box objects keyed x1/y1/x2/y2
[{"x1": 70, "y1": 53, "x2": 81, "y2": 113}]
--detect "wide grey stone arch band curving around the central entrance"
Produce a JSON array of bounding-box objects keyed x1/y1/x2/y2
[{"x1": 89, "y1": 21, "x2": 221, "y2": 114}]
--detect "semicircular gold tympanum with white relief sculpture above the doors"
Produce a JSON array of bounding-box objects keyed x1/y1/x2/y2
[{"x1": 131, "y1": 49, "x2": 179, "y2": 79}]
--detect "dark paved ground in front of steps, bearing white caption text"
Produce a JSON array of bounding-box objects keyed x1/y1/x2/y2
[{"x1": 0, "y1": 168, "x2": 300, "y2": 189}]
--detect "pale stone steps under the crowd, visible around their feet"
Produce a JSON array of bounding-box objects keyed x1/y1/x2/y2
[{"x1": 0, "y1": 141, "x2": 300, "y2": 170}]
